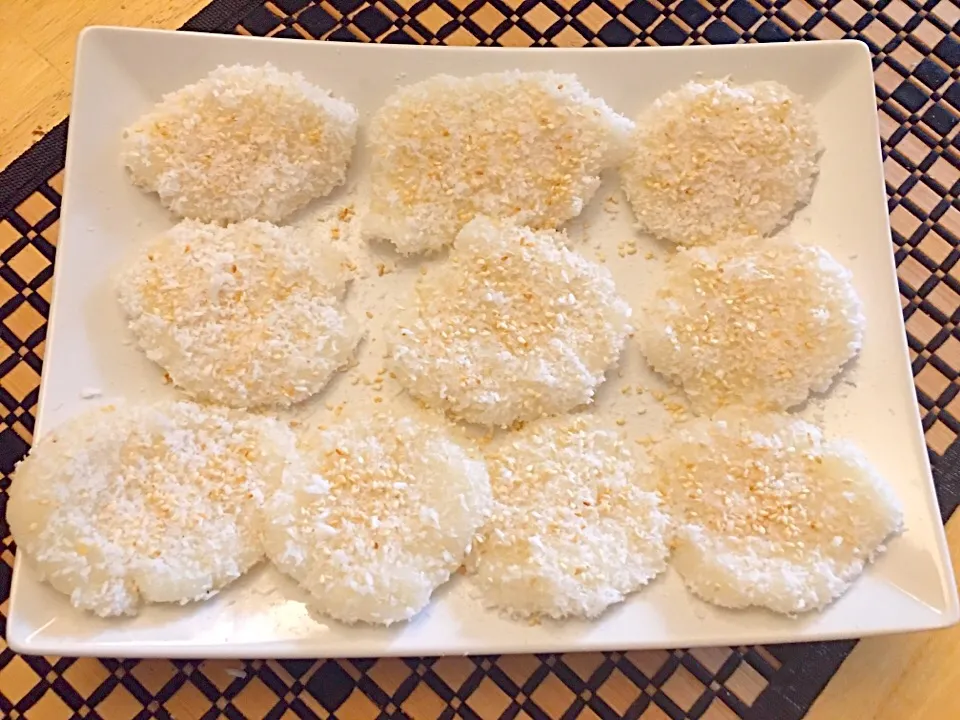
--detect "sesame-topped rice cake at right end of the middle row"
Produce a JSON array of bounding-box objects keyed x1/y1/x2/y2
[{"x1": 636, "y1": 236, "x2": 866, "y2": 413}]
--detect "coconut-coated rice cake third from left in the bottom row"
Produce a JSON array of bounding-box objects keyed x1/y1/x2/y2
[{"x1": 471, "y1": 417, "x2": 670, "y2": 619}]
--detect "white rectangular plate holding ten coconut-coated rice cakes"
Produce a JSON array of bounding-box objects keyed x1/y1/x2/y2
[{"x1": 7, "y1": 28, "x2": 958, "y2": 658}]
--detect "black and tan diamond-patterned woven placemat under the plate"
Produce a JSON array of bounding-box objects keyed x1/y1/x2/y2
[{"x1": 0, "y1": 0, "x2": 960, "y2": 720}]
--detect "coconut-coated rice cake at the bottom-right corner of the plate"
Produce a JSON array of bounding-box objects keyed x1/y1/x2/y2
[{"x1": 653, "y1": 414, "x2": 903, "y2": 614}]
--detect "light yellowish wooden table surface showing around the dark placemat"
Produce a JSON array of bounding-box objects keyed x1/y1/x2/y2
[{"x1": 0, "y1": 0, "x2": 960, "y2": 720}]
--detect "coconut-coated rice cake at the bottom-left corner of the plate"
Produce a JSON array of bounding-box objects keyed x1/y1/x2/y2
[{"x1": 7, "y1": 402, "x2": 294, "y2": 617}]
